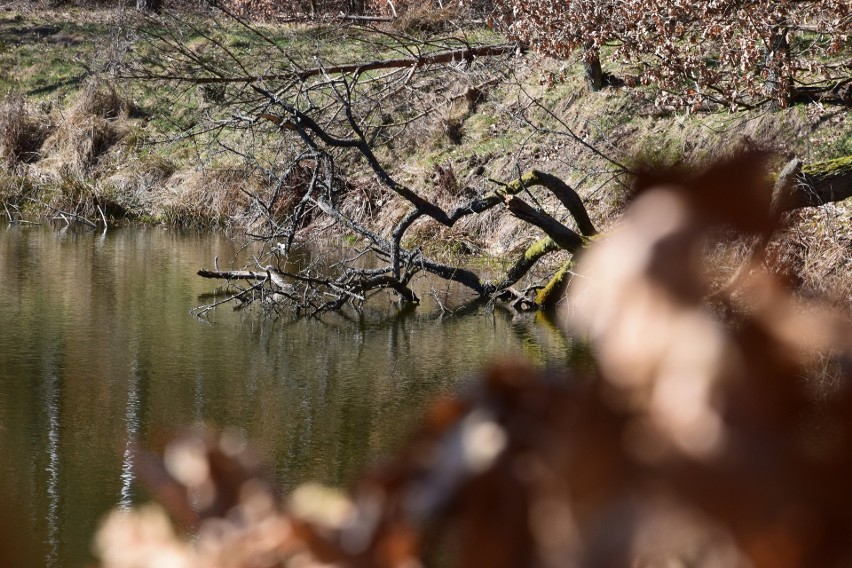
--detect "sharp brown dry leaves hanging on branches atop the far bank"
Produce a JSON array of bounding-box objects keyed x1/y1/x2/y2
[{"x1": 494, "y1": 0, "x2": 852, "y2": 108}]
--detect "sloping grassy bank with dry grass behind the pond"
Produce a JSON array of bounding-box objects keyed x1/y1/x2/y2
[{"x1": 0, "y1": 5, "x2": 852, "y2": 305}]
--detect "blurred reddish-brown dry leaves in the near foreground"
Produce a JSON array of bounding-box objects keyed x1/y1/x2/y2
[{"x1": 97, "y1": 154, "x2": 852, "y2": 568}]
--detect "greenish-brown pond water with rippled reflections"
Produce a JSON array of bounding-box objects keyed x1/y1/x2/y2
[{"x1": 0, "y1": 226, "x2": 568, "y2": 568}]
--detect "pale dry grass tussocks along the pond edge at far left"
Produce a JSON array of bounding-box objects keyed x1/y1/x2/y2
[{"x1": 0, "y1": 73, "x2": 272, "y2": 227}]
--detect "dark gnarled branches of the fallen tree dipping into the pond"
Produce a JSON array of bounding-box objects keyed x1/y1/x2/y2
[{"x1": 198, "y1": 164, "x2": 597, "y2": 313}]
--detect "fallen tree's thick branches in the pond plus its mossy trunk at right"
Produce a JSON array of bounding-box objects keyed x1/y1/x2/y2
[{"x1": 198, "y1": 153, "x2": 852, "y2": 313}]
